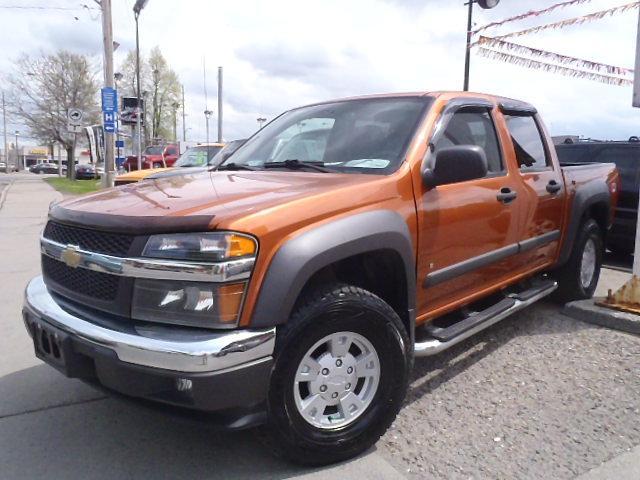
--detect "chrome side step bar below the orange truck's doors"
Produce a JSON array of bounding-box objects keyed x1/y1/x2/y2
[{"x1": 414, "y1": 281, "x2": 558, "y2": 357}]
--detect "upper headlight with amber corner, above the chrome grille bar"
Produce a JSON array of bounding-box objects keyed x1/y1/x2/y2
[{"x1": 142, "y1": 232, "x2": 257, "y2": 262}]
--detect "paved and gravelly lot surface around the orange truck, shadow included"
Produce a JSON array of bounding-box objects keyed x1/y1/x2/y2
[{"x1": 0, "y1": 174, "x2": 640, "y2": 479}]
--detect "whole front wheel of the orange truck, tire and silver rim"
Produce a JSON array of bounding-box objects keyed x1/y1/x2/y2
[{"x1": 268, "y1": 284, "x2": 411, "y2": 465}]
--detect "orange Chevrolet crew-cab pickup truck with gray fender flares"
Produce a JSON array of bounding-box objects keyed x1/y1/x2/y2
[{"x1": 23, "y1": 92, "x2": 618, "y2": 464}]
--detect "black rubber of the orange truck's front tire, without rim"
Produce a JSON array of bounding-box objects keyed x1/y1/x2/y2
[{"x1": 266, "y1": 284, "x2": 412, "y2": 466}]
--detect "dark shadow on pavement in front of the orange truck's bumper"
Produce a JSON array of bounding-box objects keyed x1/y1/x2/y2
[{"x1": 0, "y1": 365, "x2": 370, "y2": 480}]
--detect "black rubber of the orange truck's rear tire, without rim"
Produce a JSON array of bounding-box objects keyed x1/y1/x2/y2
[{"x1": 555, "y1": 219, "x2": 604, "y2": 302}]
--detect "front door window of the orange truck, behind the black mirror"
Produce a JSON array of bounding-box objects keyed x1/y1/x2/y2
[{"x1": 435, "y1": 110, "x2": 504, "y2": 173}]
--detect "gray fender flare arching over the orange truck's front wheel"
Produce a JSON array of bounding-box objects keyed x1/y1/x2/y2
[{"x1": 251, "y1": 210, "x2": 416, "y2": 336}]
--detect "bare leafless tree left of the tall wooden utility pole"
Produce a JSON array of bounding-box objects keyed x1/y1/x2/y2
[{"x1": 7, "y1": 50, "x2": 98, "y2": 178}]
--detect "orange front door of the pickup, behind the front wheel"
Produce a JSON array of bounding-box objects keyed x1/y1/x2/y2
[{"x1": 417, "y1": 98, "x2": 521, "y2": 322}]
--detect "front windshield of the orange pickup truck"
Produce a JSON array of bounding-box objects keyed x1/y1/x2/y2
[{"x1": 220, "y1": 97, "x2": 431, "y2": 174}]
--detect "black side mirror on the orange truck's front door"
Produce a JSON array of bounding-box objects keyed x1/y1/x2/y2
[{"x1": 422, "y1": 145, "x2": 487, "y2": 188}]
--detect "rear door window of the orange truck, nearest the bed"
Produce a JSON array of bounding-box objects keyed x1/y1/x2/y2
[{"x1": 505, "y1": 115, "x2": 551, "y2": 170}]
